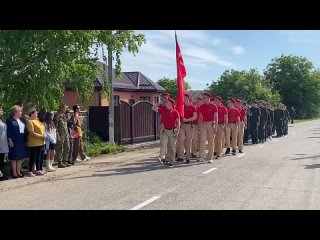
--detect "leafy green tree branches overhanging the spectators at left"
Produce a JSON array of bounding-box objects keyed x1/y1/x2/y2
[{"x1": 0, "y1": 30, "x2": 145, "y2": 109}]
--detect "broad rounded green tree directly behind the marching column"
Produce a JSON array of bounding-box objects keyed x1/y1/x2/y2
[{"x1": 208, "y1": 69, "x2": 280, "y2": 105}]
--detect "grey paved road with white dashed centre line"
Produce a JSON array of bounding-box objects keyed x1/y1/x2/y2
[{"x1": 0, "y1": 121, "x2": 320, "y2": 210}]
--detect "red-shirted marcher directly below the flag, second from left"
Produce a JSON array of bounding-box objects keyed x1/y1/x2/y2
[{"x1": 177, "y1": 93, "x2": 198, "y2": 163}]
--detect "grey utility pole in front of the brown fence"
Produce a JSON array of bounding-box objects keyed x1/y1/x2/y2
[{"x1": 108, "y1": 46, "x2": 114, "y2": 143}]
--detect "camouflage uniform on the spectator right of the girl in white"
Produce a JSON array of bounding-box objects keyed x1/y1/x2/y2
[{"x1": 54, "y1": 113, "x2": 70, "y2": 167}]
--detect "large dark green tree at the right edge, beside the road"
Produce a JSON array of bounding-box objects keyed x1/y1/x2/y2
[{"x1": 264, "y1": 55, "x2": 320, "y2": 117}]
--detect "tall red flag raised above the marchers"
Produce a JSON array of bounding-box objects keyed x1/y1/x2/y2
[{"x1": 175, "y1": 33, "x2": 187, "y2": 118}]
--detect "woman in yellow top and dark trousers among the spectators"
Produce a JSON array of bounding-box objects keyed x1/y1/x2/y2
[{"x1": 27, "y1": 107, "x2": 46, "y2": 177}]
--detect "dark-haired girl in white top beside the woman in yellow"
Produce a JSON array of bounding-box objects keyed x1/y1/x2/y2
[{"x1": 44, "y1": 112, "x2": 57, "y2": 172}]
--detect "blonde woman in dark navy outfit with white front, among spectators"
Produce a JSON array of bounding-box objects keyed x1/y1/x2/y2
[{"x1": 6, "y1": 105, "x2": 27, "y2": 178}]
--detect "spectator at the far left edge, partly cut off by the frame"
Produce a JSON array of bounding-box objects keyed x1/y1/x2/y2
[{"x1": 0, "y1": 107, "x2": 9, "y2": 181}]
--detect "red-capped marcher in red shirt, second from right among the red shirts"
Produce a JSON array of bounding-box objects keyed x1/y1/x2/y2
[{"x1": 225, "y1": 98, "x2": 240, "y2": 155}]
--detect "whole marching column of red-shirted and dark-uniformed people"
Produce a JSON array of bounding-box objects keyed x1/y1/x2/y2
[{"x1": 152, "y1": 92, "x2": 295, "y2": 167}]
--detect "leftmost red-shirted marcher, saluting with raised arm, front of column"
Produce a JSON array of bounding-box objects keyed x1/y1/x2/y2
[{"x1": 152, "y1": 98, "x2": 180, "y2": 167}]
